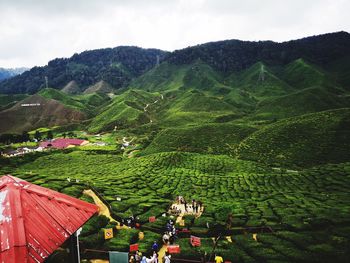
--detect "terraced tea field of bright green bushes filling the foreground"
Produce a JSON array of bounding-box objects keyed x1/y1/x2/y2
[{"x1": 1, "y1": 149, "x2": 350, "y2": 262}]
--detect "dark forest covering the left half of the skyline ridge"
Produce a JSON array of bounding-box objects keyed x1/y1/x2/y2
[{"x1": 0, "y1": 46, "x2": 165, "y2": 94}]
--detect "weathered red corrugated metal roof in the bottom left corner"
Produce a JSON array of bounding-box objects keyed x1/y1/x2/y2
[{"x1": 0, "y1": 175, "x2": 98, "y2": 263}]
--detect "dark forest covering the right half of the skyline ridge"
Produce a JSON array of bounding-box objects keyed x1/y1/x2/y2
[{"x1": 166, "y1": 32, "x2": 350, "y2": 72}]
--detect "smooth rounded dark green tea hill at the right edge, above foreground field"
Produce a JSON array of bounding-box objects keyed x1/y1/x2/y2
[{"x1": 237, "y1": 108, "x2": 350, "y2": 166}]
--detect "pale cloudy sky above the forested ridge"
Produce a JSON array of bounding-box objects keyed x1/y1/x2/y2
[{"x1": 0, "y1": 0, "x2": 350, "y2": 67}]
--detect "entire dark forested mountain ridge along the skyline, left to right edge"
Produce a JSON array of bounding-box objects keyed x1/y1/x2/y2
[{"x1": 0, "y1": 31, "x2": 350, "y2": 94}]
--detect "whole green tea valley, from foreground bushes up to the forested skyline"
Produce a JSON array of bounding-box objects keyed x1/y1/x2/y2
[{"x1": 0, "y1": 32, "x2": 350, "y2": 262}]
